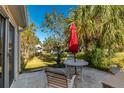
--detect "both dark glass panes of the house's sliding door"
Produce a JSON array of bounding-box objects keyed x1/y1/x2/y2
[{"x1": 0, "y1": 15, "x2": 15, "y2": 88}]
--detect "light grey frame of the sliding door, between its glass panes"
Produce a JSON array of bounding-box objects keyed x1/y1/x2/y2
[{"x1": 0, "y1": 9, "x2": 15, "y2": 88}]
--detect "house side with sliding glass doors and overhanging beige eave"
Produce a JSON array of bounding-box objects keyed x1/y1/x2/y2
[{"x1": 0, "y1": 5, "x2": 28, "y2": 87}]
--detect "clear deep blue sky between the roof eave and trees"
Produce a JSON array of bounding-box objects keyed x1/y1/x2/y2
[{"x1": 27, "y1": 5, "x2": 76, "y2": 41}]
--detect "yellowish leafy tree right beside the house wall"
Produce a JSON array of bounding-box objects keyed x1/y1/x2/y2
[{"x1": 21, "y1": 23, "x2": 40, "y2": 67}]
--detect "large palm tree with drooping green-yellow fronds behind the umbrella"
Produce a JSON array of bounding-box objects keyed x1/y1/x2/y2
[{"x1": 65, "y1": 5, "x2": 124, "y2": 56}]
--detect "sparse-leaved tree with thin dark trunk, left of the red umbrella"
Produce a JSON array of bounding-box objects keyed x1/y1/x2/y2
[{"x1": 41, "y1": 10, "x2": 65, "y2": 64}]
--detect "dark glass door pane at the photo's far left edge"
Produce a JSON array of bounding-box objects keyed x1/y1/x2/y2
[{"x1": 0, "y1": 15, "x2": 5, "y2": 88}]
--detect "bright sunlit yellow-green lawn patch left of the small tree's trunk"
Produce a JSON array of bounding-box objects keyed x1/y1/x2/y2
[{"x1": 25, "y1": 57, "x2": 56, "y2": 70}]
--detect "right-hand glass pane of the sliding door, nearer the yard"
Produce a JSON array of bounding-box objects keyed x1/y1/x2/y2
[{"x1": 8, "y1": 23, "x2": 15, "y2": 85}]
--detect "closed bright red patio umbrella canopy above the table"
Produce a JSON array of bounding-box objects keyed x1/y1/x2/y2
[{"x1": 69, "y1": 23, "x2": 78, "y2": 54}]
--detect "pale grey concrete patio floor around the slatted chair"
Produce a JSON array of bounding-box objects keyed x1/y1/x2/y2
[{"x1": 12, "y1": 67, "x2": 112, "y2": 88}]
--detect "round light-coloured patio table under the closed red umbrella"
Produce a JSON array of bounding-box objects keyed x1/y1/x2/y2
[{"x1": 64, "y1": 60, "x2": 88, "y2": 87}]
